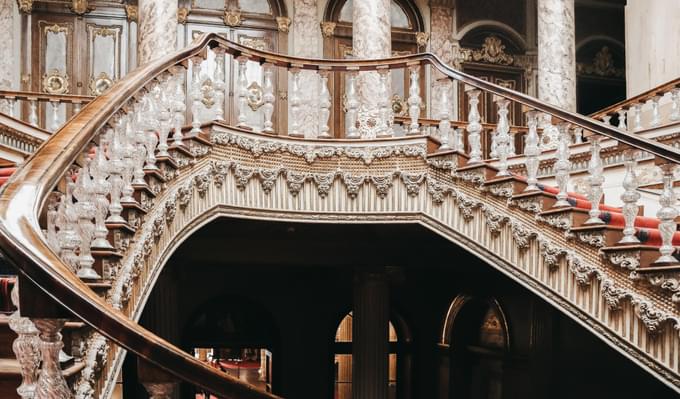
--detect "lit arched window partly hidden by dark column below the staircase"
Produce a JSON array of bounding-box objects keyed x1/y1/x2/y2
[{"x1": 333, "y1": 312, "x2": 410, "y2": 399}]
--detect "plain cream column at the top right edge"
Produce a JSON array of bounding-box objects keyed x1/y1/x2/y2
[{"x1": 626, "y1": 0, "x2": 680, "y2": 97}]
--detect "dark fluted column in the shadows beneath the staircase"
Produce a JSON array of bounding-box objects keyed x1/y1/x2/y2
[{"x1": 352, "y1": 272, "x2": 390, "y2": 399}]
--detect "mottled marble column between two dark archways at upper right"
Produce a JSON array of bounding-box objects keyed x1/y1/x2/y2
[{"x1": 538, "y1": 0, "x2": 576, "y2": 111}]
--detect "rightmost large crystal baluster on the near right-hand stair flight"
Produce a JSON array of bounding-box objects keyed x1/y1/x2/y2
[{"x1": 655, "y1": 163, "x2": 678, "y2": 263}]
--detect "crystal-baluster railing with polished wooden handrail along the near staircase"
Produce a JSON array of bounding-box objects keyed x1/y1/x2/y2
[{"x1": 0, "y1": 35, "x2": 680, "y2": 398}]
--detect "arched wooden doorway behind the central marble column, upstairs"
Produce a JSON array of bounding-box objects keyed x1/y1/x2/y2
[{"x1": 321, "y1": 0, "x2": 425, "y2": 137}]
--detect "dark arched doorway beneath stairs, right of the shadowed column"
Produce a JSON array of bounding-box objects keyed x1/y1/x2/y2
[{"x1": 440, "y1": 296, "x2": 509, "y2": 399}]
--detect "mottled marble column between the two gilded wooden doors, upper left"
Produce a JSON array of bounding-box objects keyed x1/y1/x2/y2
[{"x1": 137, "y1": 0, "x2": 177, "y2": 65}]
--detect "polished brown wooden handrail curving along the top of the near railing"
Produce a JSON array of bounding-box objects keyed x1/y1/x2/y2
[{"x1": 0, "y1": 34, "x2": 680, "y2": 399}]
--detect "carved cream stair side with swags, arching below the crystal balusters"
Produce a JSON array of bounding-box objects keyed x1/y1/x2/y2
[{"x1": 89, "y1": 125, "x2": 680, "y2": 397}]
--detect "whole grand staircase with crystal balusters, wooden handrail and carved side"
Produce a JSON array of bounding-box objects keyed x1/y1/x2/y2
[{"x1": 0, "y1": 35, "x2": 680, "y2": 398}]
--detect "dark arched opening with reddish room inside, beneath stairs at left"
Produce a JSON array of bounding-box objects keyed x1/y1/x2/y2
[{"x1": 182, "y1": 295, "x2": 279, "y2": 399}]
